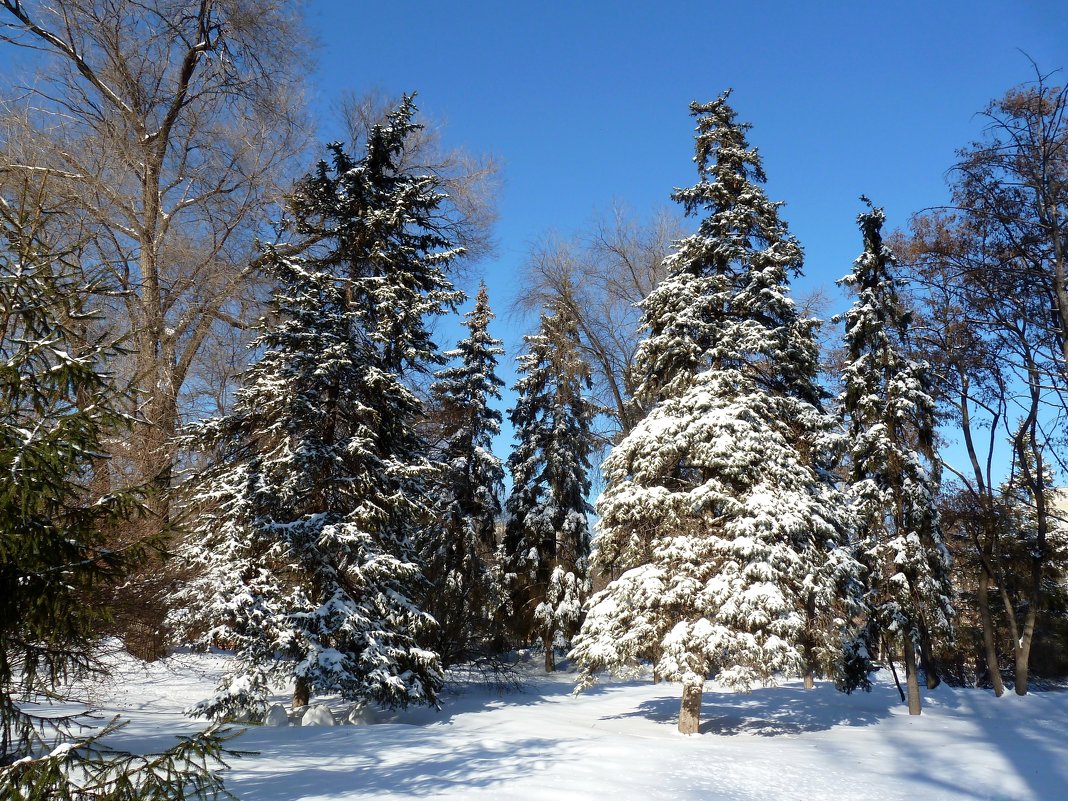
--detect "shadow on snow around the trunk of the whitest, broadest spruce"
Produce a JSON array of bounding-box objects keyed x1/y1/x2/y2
[{"x1": 613, "y1": 682, "x2": 900, "y2": 737}]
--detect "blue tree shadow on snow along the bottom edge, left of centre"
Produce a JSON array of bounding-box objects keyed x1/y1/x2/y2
[{"x1": 226, "y1": 726, "x2": 568, "y2": 801}]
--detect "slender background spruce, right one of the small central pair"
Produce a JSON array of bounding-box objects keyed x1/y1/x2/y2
[{"x1": 501, "y1": 309, "x2": 596, "y2": 672}]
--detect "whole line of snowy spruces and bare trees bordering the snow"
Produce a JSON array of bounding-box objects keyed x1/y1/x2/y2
[{"x1": 0, "y1": 0, "x2": 1068, "y2": 798}]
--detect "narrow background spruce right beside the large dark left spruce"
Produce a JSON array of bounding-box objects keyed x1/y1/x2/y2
[{"x1": 421, "y1": 284, "x2": 504, "y2": 666}]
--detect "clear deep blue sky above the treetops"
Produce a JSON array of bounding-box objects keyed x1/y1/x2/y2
[{"x1": 308, "y1": 0, "x2": 1068, "y2": 474}]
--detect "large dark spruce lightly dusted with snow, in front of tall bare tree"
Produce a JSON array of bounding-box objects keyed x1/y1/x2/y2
[{"x1": 175, "y1": 97, "x2": 459, "y2": 717}]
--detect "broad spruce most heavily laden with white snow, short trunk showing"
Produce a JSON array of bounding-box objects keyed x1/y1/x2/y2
[{"x1": 571, "y1": 94, "x2": 859, "y2": 734}]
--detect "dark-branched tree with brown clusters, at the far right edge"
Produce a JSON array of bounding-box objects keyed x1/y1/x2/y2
[{"x1": 906, "y1": 68, "x2": 1068, "y2": 694}]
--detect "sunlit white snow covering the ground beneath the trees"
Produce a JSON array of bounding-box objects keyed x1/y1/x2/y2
[{"x1": 64, "y1": 654, "x2": 1068, "y2": 801}]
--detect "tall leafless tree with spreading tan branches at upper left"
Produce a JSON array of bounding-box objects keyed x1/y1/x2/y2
[{"x1": 0, "y1": 0, "x2": 308, "y2": 517}]
